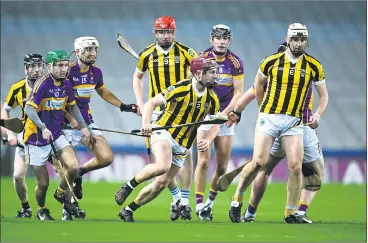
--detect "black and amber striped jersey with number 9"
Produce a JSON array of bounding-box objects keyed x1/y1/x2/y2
[{"x1": 137, "y1": 41, "x2": 197, "y2": 99}]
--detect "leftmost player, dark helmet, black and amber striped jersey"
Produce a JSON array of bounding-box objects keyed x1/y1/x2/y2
[{"x1": 1, "y1": 53, "x2": 44, "y2": 218}]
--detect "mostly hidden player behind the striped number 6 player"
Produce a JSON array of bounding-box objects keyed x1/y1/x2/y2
[{"x1": 227, "y1": 42, "x2": 324, "y2": 223}]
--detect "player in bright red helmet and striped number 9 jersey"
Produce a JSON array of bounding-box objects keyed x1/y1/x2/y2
[{"x1": 127, "y1": 16, "x2": 197, "y2": 220}]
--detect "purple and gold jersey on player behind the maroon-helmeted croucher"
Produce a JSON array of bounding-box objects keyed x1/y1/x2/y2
[{"x1": 201, "y1": 48, "x2": 244, "y2": 111}]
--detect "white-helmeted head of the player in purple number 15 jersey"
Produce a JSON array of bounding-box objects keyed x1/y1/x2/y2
[{"x1": 74, "y1": 36, "x2": 100, "y2": 65}]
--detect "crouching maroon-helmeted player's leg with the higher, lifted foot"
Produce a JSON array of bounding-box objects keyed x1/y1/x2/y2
[{"x1": 115, "y1": 131, "x2": 172, "y2": 205}]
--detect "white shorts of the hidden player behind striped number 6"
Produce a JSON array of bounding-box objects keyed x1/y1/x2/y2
[{"x1": 270, "y1": 126, "x2": 322, "y2": 164}]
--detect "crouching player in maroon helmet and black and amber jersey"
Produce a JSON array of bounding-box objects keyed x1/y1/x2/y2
[{"x1": 117, "y1": 56, "x2": 220, "y2": 222}]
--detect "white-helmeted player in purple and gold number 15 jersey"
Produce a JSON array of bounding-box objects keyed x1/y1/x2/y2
[{"x1": 63, "y1": 37, "x2": 139, "y2": 219}]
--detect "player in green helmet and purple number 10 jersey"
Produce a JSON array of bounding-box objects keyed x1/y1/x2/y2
[{"x1": 23, "y1": 50, "x2": 91, "y2": 220}]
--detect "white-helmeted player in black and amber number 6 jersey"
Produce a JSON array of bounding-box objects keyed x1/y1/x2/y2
[{"x1": 229, "y1": 23, "x2": 328, "y2": 224}]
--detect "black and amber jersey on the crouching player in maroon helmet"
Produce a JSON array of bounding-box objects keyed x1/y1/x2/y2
[{"x1": 155, "y1": 80, "x2": 220, "y2": 149}]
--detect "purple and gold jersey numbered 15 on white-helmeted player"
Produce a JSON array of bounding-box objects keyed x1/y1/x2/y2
[{"x1": 64, "y1": 61, "x2": 104, "y2": 126}]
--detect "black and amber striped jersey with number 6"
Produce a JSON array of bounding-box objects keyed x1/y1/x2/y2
[{"x1": 258, "y1": 52, "x2": 325, "y2": 117}]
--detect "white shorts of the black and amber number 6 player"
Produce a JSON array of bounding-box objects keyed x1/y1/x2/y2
[{"x1": 255, "y1": 113, "x2": 303, "y2": 138}]
